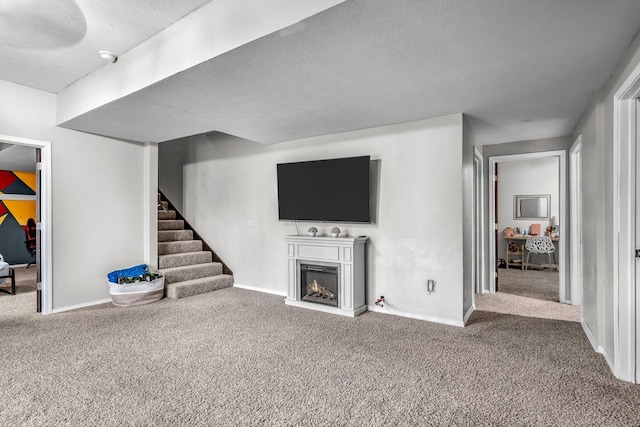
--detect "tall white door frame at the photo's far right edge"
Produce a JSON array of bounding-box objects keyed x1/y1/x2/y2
[{"x1": 611, "y1": 58, "x2": 640, "y2": 383}]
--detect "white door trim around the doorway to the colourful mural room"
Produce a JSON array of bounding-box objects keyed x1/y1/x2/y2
[{"x1": 0, "y1": 135, "x2": 53, "y2": 314}]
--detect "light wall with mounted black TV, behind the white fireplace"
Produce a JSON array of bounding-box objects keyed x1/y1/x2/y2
[{"x1": 159, "y1": 114, "x2": 464, "y2": 325}]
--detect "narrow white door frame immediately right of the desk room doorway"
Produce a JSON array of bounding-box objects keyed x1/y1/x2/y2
[{"x1": 569, "y1": 135, "x2": 583, "y2": 313}]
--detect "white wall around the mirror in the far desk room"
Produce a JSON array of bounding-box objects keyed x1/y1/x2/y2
[{"x1": 498, "y1": 157, "x2": 560, "y2": 259}]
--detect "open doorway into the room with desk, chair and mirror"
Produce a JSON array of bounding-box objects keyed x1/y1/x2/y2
[{"x1": 489, "y1": 151, "x2": 570, "y2": 303}]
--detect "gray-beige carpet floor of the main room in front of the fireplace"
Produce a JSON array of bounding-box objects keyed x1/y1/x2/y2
[{"x1": 0, "y1": 282, "x2": 640, "y2": 426}]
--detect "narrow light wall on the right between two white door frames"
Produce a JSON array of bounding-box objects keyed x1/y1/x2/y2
[{"x1": 573, "y1": 30, "x2": 640, "y2": 372}]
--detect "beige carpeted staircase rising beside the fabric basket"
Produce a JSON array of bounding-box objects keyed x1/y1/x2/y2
[{"x1": 158, "y1": 201, "x2": 233, "y2": 299}]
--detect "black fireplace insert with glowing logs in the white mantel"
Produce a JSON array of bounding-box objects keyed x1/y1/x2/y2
[{"x1": 300, "y1": 264, "x2": 339, "y2": 307}]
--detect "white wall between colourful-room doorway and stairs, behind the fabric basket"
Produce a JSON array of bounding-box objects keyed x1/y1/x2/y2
[{"x1": 0, "y1": 81, "x2": 150, "y2": 310}]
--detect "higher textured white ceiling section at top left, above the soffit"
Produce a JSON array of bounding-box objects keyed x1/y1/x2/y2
[{"x1": 0, "y1": 0, "x2": 210, "y2": 93}]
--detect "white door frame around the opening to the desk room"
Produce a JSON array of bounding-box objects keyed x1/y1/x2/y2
[{"x1": 487, "y1": 150, "x2": 570, "y2": 304}]
